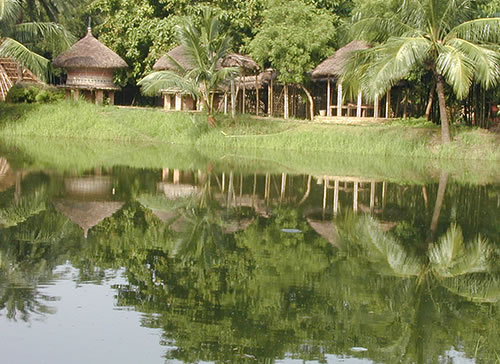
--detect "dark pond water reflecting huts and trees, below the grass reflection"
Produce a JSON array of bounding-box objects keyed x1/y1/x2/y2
[{"x1": 0, "y1": 149, "x2": 500, "y2": 364}]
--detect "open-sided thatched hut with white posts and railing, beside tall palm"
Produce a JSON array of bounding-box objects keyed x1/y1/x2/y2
[{"x1": 311, "y1": 40, "x2": 390, "y2": 118}]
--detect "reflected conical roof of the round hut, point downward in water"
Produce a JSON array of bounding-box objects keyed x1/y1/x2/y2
[{"x1": 54, "y1": 200, "x2": 123, "y2": 237}]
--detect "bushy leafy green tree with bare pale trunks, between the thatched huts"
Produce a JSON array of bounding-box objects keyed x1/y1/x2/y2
[{"x1": 248, "y1": 0, "x2": 336, "y2": 119}]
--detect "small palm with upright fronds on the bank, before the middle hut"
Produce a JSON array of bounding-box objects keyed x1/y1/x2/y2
[{"x1": 139, "y1": 8, "x2": 238, "y2": 126}]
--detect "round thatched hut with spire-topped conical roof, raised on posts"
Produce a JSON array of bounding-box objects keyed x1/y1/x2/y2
[{"x1": 52, "y1": 27, "x2": 128, "y2": 104}]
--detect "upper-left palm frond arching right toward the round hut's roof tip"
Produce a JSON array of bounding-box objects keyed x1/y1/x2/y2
[{"x1": 12, "y1": 22, "x2": 76, "y2": 52}]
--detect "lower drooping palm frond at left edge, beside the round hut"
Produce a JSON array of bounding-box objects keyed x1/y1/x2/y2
[{"x1": 0, "y1": 38, "x2": 49, "y2": 80}]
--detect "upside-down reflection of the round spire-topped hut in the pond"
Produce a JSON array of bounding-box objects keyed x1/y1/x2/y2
[{"x1": 54, "y1": 176, "x2": 123, "y2": 237}]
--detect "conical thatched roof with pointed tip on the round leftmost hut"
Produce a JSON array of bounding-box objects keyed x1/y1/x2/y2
[{"x1": 52, "y1": 29, "x2": 128, "y2": 68}]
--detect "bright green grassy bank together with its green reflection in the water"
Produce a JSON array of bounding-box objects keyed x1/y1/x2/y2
[{"x1": 0, "y1": 102, "x2": 500, "y2": 183}]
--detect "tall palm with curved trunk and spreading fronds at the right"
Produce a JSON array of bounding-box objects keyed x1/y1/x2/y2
[{"x1": 345, "y1": 0, "x2": 500, "y2": 143}]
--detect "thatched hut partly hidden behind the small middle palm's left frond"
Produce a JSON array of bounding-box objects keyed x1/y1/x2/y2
[{"x1": 153, "y1": 45, "x2": 196, "y2": 111}]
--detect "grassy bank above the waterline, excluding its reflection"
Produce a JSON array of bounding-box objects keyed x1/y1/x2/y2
[{"x1": 0, "y1": 102, "x2": 500, "y2": 163}]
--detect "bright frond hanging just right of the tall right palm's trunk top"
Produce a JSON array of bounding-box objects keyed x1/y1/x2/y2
[{"x1": 436, "y1": 44, "x2": 476, "y2": 99}]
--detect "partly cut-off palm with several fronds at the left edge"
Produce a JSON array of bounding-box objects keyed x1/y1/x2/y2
[{"x1": 0, "y1": 0, "x2": 75, "y2": 80}]
